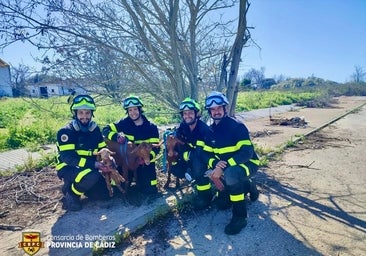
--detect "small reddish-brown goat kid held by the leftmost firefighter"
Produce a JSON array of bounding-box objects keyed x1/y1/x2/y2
[{"x1": 96, "y1": 148, "x2": 126, "y2": 197}]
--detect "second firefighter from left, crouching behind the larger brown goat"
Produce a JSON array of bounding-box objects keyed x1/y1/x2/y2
[{"x1": 102, "y1": 96, "x2": 160, "y2": 195}]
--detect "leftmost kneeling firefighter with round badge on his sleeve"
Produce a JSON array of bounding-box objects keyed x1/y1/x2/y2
[{"x1": 56, "y1": 95, "x2": 109, "y2": 211}]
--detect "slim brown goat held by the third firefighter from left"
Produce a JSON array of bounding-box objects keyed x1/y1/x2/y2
[{"x1": 163, "y1": 131, "x2": 184, "y2": 188}]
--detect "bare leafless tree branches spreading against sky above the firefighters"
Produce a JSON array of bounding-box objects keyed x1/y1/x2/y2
[{"x1": 0, "y1": 0, "x2": 252, "y2": 108}]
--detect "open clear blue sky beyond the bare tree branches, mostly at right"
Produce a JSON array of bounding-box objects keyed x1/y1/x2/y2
[{"x1": 0, "y1": 0, "x2": 366, "y2": 83}]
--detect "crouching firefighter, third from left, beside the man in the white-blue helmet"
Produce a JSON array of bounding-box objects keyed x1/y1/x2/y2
[{"x1": 171, "y1": 98, "x2": 212, "y2": 209}]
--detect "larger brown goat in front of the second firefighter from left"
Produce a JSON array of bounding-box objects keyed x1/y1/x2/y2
[{"x1": 106, "y1": 140, "x2": 155, "y2": 189}]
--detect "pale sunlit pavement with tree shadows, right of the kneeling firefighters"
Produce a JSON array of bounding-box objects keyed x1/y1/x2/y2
[{"x1": 111, "y1": 98, "x2": 366, "y2": 256}]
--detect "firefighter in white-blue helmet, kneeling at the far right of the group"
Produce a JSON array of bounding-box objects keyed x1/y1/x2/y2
[{"x1": 204, "y1": 91, "x2": 259, "y2": 235}]
